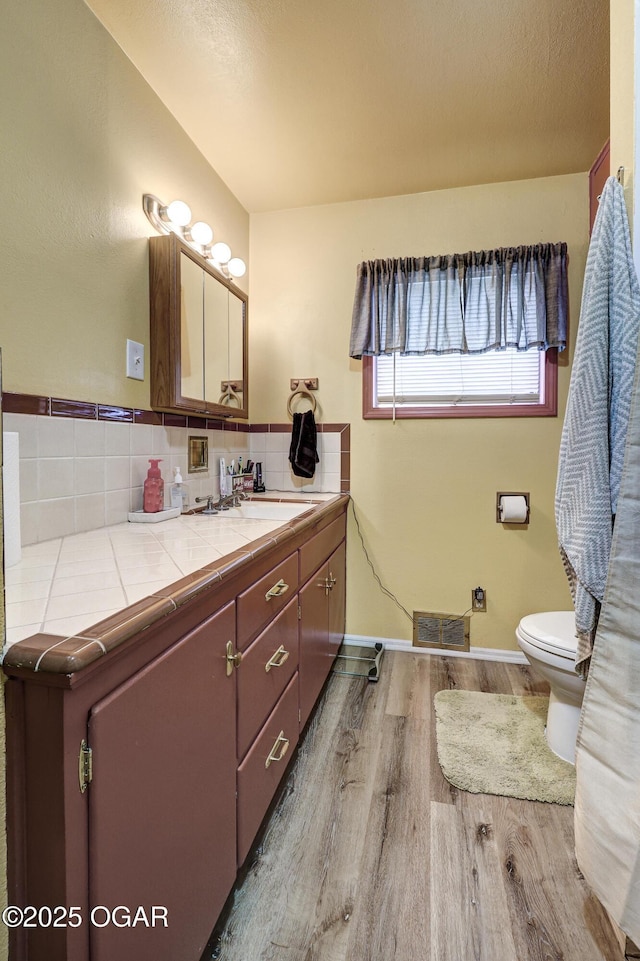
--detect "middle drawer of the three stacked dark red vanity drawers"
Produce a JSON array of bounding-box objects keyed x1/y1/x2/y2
[{"x1": 237, "y1": 596, "x2": 298, "y2": 758}]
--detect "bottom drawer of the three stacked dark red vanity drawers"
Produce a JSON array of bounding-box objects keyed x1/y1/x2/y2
[{"x1": 238, "y1": 674, "x2": 298, "y2": 866}]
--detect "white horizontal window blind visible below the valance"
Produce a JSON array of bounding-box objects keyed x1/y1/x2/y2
[{"x1": 374, "y1": 348, "x2": 544, "y2": 407}]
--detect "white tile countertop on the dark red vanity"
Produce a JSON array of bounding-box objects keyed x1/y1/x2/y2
[{"x1": 3, "y1": 492, "x2": 347, "y2": 669}]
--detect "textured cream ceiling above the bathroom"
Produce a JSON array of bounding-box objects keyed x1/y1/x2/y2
[{"x1": 82, "y1": 0, "x2": 609, "y2": 212}]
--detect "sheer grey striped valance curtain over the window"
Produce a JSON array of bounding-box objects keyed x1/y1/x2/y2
[{"x1": 349, "y1": 243, "x2": 568, "y2": 359}]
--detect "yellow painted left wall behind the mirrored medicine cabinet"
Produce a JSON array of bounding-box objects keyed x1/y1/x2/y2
[{"x1": 0, "y1": 0, "x2": 249, "y2": 407}]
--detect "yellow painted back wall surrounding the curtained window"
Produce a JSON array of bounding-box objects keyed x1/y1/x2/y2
[{"x1": 251, "y1": 174, "x2": 588, "y2": 648}]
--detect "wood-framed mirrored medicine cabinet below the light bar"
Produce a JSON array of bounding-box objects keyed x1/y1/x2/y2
[{"x1": 149, "y1": 234, "x2": 248, "y2": 417}]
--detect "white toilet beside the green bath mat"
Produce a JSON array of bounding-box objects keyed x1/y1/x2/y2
[{"x1": 516, "y1": 611, "x2": 585, "y2": 764}]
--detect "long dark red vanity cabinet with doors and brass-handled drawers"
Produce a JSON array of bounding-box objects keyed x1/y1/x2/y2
[{"x1": 4, "y1": 497, "x2": 348, "y2": 961}]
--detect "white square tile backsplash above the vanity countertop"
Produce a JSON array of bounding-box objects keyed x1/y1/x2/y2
[{"x1": 3, "y1": 414, "x2": 341, "y2": 548}]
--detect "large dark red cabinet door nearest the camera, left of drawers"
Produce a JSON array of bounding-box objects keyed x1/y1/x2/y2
[{"x1": 89, "y1": 603, "x2": 236, "y2": 961}]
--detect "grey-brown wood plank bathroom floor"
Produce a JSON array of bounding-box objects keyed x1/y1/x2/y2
[{"x1": 204, "y1": 652, "x2": 624, "y2": 961}]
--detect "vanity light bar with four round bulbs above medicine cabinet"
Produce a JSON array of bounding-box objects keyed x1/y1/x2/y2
[{"x1": 142, "y1": 194, "x2": 247, "y2": 279}]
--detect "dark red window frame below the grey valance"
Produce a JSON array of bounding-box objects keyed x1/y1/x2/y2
[{"x1": 362, "y1": 347, "x2": 558, "y2": 420}]
